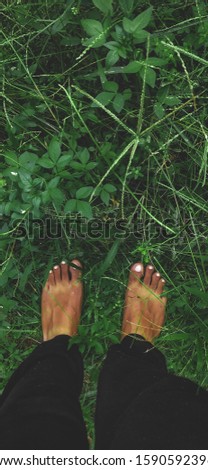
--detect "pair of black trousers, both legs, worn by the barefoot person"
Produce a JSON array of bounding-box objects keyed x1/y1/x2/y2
[{"x1": 0, "y1": 335, "x2": 208, "y2": 450}]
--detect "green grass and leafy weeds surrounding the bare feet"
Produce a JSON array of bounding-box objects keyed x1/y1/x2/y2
[{"x1": 0, "y1": 0, "x2": 208, "y2": 440}]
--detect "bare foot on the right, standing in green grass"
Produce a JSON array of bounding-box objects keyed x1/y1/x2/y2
[{"x1": 121, "y1": 263, "x2": 167, "y2": 343}]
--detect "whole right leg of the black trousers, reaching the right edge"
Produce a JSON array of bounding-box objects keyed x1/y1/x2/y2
[{"x1": 95, "y1": 335, "x2": 208, "y2": 450}]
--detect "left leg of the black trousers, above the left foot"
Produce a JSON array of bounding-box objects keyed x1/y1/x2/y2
[{"x1": 0, "y1": 335, "x2": 88, "y2": 449}]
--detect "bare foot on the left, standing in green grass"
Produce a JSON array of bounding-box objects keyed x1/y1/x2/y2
[{"x1": 41, "y1": 260, "x2": 83, "y2": 341}]
